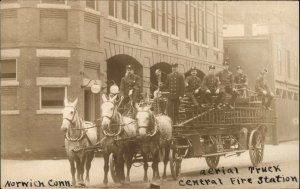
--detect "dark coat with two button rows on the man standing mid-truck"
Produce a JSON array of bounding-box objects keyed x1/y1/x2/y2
[{"x1": 164, "y1": 72, "x2": 185, "y2": 99}]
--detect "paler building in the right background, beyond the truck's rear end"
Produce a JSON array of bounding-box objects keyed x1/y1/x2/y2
[{"x1": 223, "y1": 1, "x2": 299, "y2": 144}]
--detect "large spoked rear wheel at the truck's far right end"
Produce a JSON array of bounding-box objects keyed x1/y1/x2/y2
[{"x1": 249, "y1": 130, "x2": 265, "y2": 166}]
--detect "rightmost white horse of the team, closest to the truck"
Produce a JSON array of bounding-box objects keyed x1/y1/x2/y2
[{"x1": 135, "y1": 104, "x2": 172, "y2": 181}]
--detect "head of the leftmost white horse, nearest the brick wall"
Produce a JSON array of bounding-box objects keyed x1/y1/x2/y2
[{"x1": 60, "y1": 98, "x2": 78, "y2": 133}]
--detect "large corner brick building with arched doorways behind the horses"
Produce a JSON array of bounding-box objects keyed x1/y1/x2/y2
[{"x1": 1, "y1": 0, "x2": 223, "y2": 156}]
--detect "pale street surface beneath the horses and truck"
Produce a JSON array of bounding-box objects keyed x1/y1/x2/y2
[{"x1": 1, "y1": 141, "x2": 299, "y2": 189}]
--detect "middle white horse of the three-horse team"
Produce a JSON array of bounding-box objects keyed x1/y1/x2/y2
[{"x1": 101, "y1": 94, "x2": 136, "y2": 184}]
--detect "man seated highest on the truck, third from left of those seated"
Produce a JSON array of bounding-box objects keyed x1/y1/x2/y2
[{"x1": 216, "y1": 60, "x2": 239, "y2": 109}]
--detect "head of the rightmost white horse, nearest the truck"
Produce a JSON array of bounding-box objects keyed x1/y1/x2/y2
[{"x1": 135, "y1": 104, "x2": 157, "y2": 136}]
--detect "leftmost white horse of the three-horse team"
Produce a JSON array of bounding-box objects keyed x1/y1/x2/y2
[{"x1": 61, "y1": 98, "x2": 97, "y2": 186}]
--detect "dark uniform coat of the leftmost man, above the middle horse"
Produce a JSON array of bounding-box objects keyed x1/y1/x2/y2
[{"x1": 120, "y1": 74, "x2": 140, "y2": 102}]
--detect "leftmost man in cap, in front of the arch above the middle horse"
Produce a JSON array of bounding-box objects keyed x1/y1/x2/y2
[{"x1": 120, "y1": 64, "x2": 141, "y2": 110}]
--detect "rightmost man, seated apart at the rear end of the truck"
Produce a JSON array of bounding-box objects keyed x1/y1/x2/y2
[{"x1": 255, "y1": 69, "x2": 274, "y2": 110}]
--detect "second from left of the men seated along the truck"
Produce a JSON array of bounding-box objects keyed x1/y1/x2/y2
[{"x1": 202, "y1": 66, "x2": 222, "y2": 109}]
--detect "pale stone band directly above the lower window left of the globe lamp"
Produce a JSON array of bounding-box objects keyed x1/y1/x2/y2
[{"x1": 36, "y1": 77, "x2": 71, "y2": 86}]
